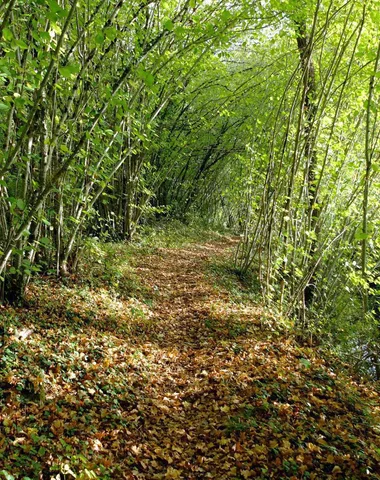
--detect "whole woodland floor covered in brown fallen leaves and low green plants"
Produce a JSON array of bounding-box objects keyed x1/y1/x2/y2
[{"x1": 0, "y1": 237, "x2": 380, "y2": 480}]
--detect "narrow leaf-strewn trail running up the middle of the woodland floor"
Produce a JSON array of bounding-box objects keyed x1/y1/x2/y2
[{"x1": 127, "y1": 239, "x2": 260, "y2": 480}]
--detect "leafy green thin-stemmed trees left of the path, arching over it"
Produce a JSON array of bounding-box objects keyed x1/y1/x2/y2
[{"x1": 0, "y1": 0, "x2": 255, "y2": 302}]
